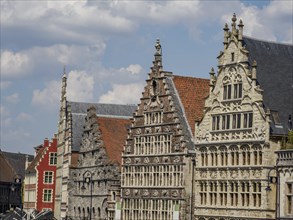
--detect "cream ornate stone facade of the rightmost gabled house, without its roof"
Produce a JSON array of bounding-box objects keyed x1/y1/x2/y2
[{"x1": 194, "y1": 14, "x2": 279, "y2": 220}]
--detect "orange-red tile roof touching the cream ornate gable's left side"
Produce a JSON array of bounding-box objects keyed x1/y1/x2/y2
[{"x1": 173, "y1": 76, "x2": 210, "y2": 134}]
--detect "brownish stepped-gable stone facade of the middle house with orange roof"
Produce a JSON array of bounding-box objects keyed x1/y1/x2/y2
[{"x1": 121, "y1": 41, "x2": 206, "y2": 220}]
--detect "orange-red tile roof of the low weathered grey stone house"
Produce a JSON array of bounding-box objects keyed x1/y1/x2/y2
[{"x1": 98, "y1": 117, "x2": 131, "y2": 165}]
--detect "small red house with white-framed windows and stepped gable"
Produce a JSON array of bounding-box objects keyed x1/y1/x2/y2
[{"x1": 23, "y1": 137, "x2": 57, "y2": 213}]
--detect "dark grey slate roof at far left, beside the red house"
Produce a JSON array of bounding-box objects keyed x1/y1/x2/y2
[{"x1": 0, "y1": 151, "x2": 34, "y2": 181}]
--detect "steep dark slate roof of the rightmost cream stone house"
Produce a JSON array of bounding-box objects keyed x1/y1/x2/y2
[{"x1": 244, "y1": 37, "x2": 293, "y2": 135}]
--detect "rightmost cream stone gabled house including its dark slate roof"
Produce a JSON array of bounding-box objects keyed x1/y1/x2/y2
[{"x1": 193, "y1": 14, "x2": 293, "y2": 220}]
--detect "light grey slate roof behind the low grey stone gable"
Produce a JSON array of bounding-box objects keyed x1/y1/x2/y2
[{"x1": 68, "y1": 101, "x2": 137, "y2": 152}]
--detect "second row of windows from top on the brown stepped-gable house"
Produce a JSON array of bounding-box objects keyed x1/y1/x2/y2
[{"x1": 134, "y1": 134, "x2": 172, "y2": 155}]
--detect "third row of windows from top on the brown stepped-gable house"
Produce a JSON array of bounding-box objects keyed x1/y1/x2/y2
[{"x1": 122, "y1": 165, "x2": 183, "y2": 186}]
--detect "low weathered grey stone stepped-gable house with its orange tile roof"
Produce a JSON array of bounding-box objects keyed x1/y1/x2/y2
[{"x1": 68, "y1": 106, "x2": 130, "y2": 220}]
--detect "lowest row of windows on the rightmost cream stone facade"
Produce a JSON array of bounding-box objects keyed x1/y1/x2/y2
[{"x1": 199, "y1": 181, "x2": 262, "y2": 207}]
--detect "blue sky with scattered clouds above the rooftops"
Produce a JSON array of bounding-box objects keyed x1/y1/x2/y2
[{"x1": 0, "y1": 0, "x2": 293, "y2": 153}]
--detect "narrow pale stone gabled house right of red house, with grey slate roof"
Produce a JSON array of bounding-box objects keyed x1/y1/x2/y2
[{"x1": 54, "y1": 70, "x2": 136, "y2": 220}]
